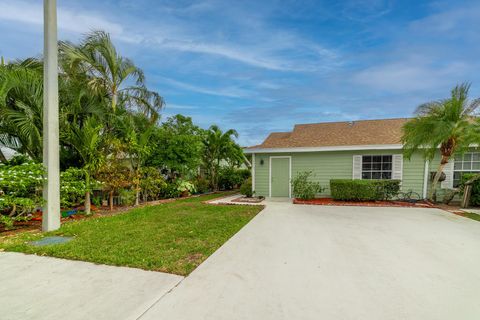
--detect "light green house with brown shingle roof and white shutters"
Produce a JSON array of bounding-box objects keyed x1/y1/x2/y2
[{"x1": 245, "y1": 118, "x2": 480, "y2": 198}]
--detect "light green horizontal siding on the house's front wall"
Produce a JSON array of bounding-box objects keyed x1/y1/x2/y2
[{"x1": 254, "y1": 150, "x2": 425, "y2": 197}]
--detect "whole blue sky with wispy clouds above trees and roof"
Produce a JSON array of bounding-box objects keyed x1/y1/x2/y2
[{"x1": 0, "y1": 0, "x2": 480, "y2": 145}]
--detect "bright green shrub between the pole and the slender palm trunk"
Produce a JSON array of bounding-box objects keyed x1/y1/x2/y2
[{"x1": 60, "y1": 167, "x2": 86, "y2": 208}]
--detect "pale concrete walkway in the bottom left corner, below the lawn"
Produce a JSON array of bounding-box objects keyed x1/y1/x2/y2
[{"x1": 0, "y1": 252, "x2": 183, "y2": 320}]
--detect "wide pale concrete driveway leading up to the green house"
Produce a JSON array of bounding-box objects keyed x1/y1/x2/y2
[{"x1": 141, "y1": 203, "x2": 480, "y2": 320}]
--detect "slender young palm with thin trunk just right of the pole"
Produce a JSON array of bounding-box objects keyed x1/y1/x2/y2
[{"x1": 65, "y1": 117, "x2": 105, "y2": 214}]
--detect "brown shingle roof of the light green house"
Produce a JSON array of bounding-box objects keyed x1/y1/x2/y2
[{"x1": 251, "y1": 118, "x2": 409, "y2": 148}]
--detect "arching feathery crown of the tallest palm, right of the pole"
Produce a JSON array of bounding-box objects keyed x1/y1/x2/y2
[{"x1": 60, "y1": 31, "x2": 164, "y2": 121}]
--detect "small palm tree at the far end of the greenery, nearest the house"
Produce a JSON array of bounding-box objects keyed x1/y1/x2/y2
[{"x1": 203, "y1": 125, "x2": 238, "y2": 191}]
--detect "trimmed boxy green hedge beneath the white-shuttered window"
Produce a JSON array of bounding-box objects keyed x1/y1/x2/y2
[{"x1": 330, "y1": 179, "x2": 400, "y2": 201}]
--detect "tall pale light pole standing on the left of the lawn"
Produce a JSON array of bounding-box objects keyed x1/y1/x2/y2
[{"x1": 42, "y1": 0, "x2": 60, "y2": 231}]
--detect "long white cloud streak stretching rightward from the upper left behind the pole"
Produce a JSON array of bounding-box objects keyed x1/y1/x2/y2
[{"x1": 0, "y1": 0, "x2": 338, "y2": 72}]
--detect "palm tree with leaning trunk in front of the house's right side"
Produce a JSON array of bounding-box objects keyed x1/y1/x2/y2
[{"x1": 402, "y1": 83, "x2": 480, "y2": 200}]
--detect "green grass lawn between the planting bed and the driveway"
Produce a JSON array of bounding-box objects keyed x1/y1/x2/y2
[{"x1": 0, "y1": 194, "x2": 262, "y2": 275}]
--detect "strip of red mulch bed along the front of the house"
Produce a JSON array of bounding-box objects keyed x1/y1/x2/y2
[{"x1": 293, "y1": 198, "x2": 436, "y2": 208}]
